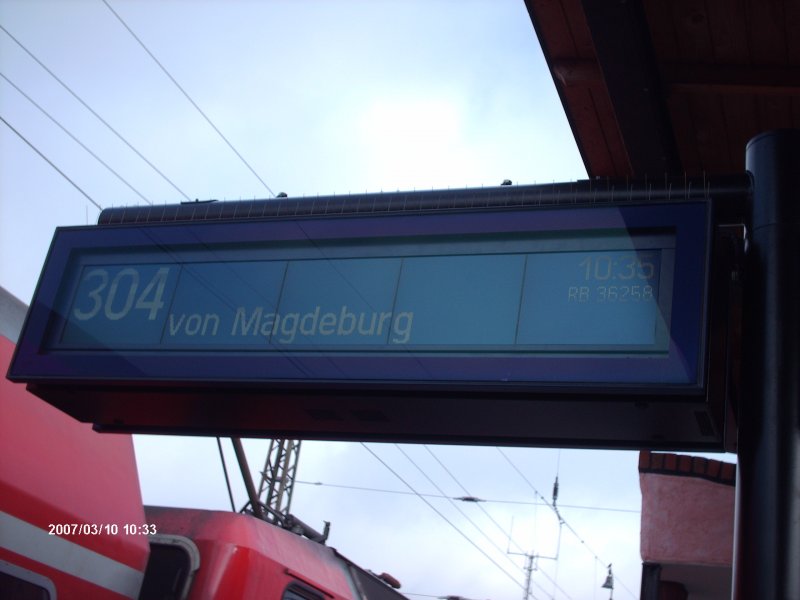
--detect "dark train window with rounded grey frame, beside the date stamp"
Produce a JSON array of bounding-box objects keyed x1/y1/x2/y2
[{"x1": 139, "y1": 534, "x2": 200, "y2": 600}]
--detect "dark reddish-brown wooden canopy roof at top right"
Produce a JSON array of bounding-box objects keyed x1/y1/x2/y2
[{"x1": 525, "y1": 0, "x2": 800, "y2": 178}]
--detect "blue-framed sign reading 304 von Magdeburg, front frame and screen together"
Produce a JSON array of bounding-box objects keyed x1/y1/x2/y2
[{"x1": 10, "y1": 202, "x2": 720, "y2": 450}]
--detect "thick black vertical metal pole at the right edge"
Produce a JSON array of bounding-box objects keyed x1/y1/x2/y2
[{"x1": 733, "y1": 130, "x2": 800, "y2": 600}]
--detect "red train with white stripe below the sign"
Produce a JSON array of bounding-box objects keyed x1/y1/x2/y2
[{"x1": 0, "y1": 288, "x2": 404, "y2": 600}]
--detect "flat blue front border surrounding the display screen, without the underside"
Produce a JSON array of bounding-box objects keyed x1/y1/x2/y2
[{"x1": 6, "y1": 203, "x2": 708, "y2": 388}]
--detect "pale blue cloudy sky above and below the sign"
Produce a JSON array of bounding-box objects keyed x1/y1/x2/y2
[{"x1": 0, "y1": 0, "x2": 716, "y2": 600}]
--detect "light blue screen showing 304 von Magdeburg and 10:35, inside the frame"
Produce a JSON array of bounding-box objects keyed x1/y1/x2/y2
[{"x1": 54, "y1": 234, "x2": 674, "y2": 353}]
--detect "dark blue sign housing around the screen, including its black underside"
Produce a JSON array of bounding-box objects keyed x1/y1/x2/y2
[{"x1": 9, "y1": 200, "x2": 721, "y2": 448}]
